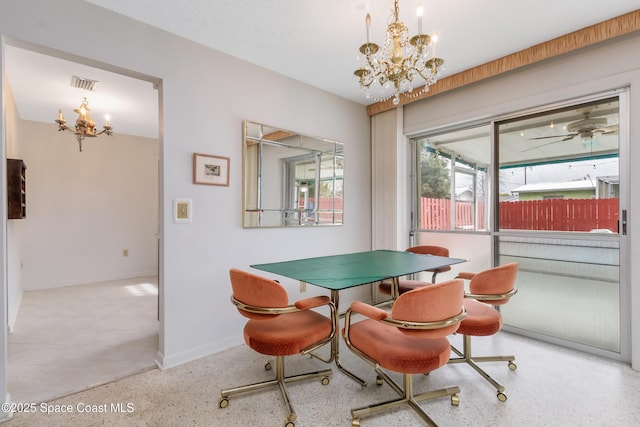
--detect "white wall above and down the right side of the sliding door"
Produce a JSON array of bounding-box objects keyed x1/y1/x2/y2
[{"x1": 392, "y1": 33, "x2": 640, "y2": 370}]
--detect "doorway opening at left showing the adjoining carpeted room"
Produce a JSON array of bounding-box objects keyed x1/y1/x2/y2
[{"x1": 4, "y1": 43, "x2": 162, "y2": 402}]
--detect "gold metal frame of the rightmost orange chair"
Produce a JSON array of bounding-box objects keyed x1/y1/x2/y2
[{"x1": 449, "y1": 263, "x2": 518, "y2": 402}]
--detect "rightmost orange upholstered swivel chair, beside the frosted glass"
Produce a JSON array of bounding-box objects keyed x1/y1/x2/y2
[{"x1": 449, "y1": 262, "x2": 518, "y2": 402}]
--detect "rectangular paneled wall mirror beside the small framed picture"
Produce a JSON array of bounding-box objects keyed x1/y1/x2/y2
[{"x1": 242, "y1": 120, "x2": 344, "y2": 228}]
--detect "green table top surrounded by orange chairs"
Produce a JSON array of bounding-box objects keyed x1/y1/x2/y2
[{"x1": 251, "y1": 250, "x2": 466, "y2": 290}]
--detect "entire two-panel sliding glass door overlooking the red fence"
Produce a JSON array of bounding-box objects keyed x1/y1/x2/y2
[{"x1": 412, "y1": 90, "x2": 630, "y2": 360}]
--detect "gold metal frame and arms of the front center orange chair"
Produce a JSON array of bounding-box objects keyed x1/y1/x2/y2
[{"x1": 343, "y1": 279, "x2": 466, "y2": 427}]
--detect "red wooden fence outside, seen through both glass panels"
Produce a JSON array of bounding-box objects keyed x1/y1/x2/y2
[{"x1": 420, "y1": 197, "x2": 619, "y2": 233}]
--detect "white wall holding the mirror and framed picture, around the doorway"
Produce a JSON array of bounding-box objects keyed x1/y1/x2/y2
[{"x1": 0, "y1": 0, "x2": 371, "y2": 404}]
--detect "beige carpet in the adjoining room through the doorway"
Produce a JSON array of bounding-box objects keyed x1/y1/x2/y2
[{"x1": 7, "y1": 276, "x2": 158, "y2": 403}]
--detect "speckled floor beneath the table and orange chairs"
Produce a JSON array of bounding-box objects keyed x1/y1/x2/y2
[{"x1": 4, "y1": 326, "x2": 640, "y2": 427}]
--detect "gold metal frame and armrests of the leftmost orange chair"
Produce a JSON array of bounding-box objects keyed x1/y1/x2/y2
[{"x1": 219, "y1": 269, "x2": 336, "y2": 427}]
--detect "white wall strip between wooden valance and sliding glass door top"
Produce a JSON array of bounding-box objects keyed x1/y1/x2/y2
[{"x1": 404, "y1": 38, "x2": 640, "y2": 135}]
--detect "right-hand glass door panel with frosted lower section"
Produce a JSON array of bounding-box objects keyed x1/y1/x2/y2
[{"x1": 494, "y1": 94, "x2": 626, "y2": 354}]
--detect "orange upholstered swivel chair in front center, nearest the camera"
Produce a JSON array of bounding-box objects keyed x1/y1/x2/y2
[{"x1": 343, "y1": 279, "x2": 465, "y2": 426}]
